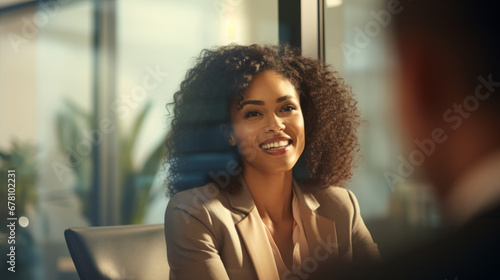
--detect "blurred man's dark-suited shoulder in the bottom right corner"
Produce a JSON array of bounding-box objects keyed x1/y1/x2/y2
[{"x1": 376, "y1": 203, "x2": 500, "y2": 280}]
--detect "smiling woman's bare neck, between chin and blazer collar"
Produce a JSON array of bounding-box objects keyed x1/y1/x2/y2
[{"x1": 243, "y1": 167, "x2": 293, "y2": 223}]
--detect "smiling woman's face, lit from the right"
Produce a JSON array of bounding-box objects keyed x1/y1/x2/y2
[{"x1": 231, "y1": 70, "x2": 305, "y2": 173}]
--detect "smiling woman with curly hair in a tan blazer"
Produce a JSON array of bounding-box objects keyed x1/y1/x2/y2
[{"x1": 165, "y1": 45, "x2": 379, "y2": 279}]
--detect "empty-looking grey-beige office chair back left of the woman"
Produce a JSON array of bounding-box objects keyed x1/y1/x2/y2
[{"x1": 64, "y1": 225, "x2": 170, "y2": 280}]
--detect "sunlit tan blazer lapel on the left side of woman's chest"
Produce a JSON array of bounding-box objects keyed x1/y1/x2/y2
[{"x1": 227, "y1": 180, "x2": 279, "y2": 279}]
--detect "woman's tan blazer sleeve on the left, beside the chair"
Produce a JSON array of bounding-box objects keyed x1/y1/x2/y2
[{"x1": 165, "y1": 197, "x2": 229, "y2": 279}]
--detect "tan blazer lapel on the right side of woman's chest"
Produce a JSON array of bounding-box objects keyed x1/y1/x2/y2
[{"x1": 293, "y1": 181, "x2": 338, "y2": 258}]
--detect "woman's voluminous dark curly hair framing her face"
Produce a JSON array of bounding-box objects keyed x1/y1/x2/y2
[{"x1": 166, "y1": 44, "x2": 361, "y2": 196}]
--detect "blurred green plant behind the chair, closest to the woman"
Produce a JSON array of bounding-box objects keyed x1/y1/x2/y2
[{"x1": 56, "y1": 100, "x2": 165, "y2": 224}]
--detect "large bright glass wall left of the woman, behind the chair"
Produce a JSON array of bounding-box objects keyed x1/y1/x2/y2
[{"x1": 0, "y1": 0, "x2": 278, "y2": 279}]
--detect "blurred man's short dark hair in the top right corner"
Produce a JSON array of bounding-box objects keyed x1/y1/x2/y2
[{"x1": 389, "y1": 0, "x2": 500, "y2": 110}]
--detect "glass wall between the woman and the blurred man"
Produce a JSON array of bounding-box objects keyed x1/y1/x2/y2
[{"x1": 324, "y1": 0, "x2": 438, "y2": 256}]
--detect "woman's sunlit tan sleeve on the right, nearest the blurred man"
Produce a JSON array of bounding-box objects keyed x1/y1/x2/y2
[{"x1": 347, "y1": 190, "x2": 381, "y2": 263}]
